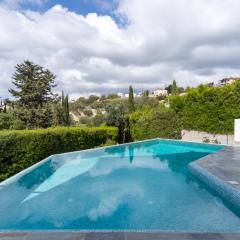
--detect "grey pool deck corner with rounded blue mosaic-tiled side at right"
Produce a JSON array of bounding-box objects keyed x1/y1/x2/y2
[{"x1": 188, "y1": 147, "x2": 240, "y2": 211}]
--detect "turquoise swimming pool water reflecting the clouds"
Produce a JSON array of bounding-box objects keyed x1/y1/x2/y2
[{"x1": 0, "y1": 140, "x2": 240, "y2": 232}]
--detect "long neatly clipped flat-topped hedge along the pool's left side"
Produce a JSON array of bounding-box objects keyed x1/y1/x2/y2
[{"x1": 0, "y1": 127, "x2": 118, "y2": 181}]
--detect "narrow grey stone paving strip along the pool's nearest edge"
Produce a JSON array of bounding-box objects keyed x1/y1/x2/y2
[{"x1": 0, "y1": 232, "x2": 240, "y2": 240}]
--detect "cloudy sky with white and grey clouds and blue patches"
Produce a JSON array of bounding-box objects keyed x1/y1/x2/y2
[{"x1": 0, "y1": 0, "x2": 240, "y2": 97}]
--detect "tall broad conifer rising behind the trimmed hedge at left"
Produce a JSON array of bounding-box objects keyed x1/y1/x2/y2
[{"x1": 9, "y1": 61, "x2": 56, "y2": 128}]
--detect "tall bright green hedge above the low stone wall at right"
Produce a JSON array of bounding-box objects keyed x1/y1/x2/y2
[{"x1": 170, "y1": 81, "x2": 240, "y2": 134}]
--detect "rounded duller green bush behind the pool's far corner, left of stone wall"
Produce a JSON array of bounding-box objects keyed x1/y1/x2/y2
[{"x1": 129, "y1": 106, "x2": 181, "y2": 140}]
